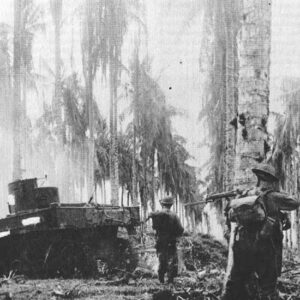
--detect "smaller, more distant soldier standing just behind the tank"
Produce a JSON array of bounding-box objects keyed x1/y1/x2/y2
[{"x1": 146, "y1": 197, "x2": 184, "y2": 283}]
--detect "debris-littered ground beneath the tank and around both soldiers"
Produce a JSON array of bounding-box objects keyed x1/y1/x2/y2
[{"x1": 0, "y1": 235, "x2": 300, "y2": 300}]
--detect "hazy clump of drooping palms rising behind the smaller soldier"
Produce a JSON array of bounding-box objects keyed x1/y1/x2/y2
[{"x1": 130, "y1": 58, "x2": 196, "y2": 216}]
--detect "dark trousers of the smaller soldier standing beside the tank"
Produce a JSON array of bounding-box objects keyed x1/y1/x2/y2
[{"x1": 157, "y1": 244, "x2": 178, "y2": 283}]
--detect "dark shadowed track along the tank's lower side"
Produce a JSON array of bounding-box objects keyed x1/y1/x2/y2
[{"x1": 0, "y1": 229, "x2": 138, "y2": 278}]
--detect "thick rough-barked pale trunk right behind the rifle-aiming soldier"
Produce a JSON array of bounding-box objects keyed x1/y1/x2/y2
[{"x1": 235, "y1": 0, "x2": 271, "y2": 188}]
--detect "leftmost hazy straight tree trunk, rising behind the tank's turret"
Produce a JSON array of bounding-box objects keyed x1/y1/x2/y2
[{"x1": 13, "y1": 0, "x2": 22, "y2": 180}]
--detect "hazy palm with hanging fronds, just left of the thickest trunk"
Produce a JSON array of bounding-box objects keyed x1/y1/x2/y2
[{"x1": 199, "y1": 0, "x2": 229, "y2": 191}]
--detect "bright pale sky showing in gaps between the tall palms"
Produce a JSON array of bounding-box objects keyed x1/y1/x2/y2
[{"x1": 0, "y1": 0, "x2": 300, "y2": 166}]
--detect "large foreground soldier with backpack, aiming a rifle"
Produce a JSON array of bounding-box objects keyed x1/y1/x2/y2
[{"x1": 222, "y1": 164, "x2": 300, "y2": 300}]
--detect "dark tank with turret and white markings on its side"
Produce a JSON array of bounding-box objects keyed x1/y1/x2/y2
[{"x1": 0, "y1": 178, "x2": 140, "y2": 278}]
